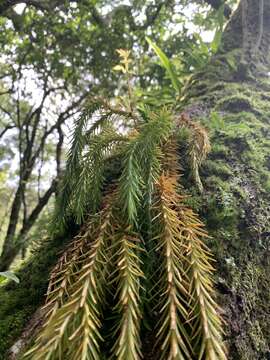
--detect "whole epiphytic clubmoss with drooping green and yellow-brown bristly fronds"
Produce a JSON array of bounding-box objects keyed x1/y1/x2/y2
[{"x1": 25, "y1": 50, "x2": 226, "y2": 360}]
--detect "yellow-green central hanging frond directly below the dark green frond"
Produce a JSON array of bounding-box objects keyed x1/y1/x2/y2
[{"x1": 112, "y1": 231, "x2": 144, "y2": 360}]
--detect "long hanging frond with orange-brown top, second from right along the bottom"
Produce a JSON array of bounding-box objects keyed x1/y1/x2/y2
[{"x1": 155, "y1": 175, "x2": 192, "y2": 360}]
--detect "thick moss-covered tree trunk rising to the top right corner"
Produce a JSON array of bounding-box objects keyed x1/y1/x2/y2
[{"x1": 0, "y1": 0, "x2": 270, "y2": 360}]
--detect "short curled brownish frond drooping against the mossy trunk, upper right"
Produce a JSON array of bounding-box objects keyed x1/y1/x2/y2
[{"x1": 177, "y1": 113, "x2": 211, "y2": 192}]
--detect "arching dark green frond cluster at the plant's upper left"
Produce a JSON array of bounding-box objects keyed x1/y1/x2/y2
[{"x1": 54, "y1": 99, "x2": 125, "y2": 227}]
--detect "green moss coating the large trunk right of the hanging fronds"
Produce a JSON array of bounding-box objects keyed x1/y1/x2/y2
[{"x1": 181, "y1": 63, "x2": 270, "y2": 360}]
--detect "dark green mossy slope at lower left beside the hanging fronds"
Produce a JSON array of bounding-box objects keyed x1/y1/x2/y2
[{"x1": 0, "y1": 229, "x2": 75, "y2": 360}]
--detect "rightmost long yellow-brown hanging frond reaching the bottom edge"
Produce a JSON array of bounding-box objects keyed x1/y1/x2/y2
[{"x1": 179, "y1": 206, "x2": 227, "y2": 360}]
